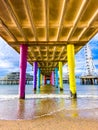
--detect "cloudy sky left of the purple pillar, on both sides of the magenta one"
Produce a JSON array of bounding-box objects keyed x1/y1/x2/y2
[{"x1": 0, "y1": 38, "x2": 32, "y2": 77}]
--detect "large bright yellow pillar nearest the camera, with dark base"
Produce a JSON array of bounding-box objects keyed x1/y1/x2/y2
[{"x1": 67, "y1": 44, "x2": 77, "y2": 98}]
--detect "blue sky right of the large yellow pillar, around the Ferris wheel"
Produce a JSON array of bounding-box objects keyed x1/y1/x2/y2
[{"x1": 75, "y1": 33, "x2": 98, "y2": 75}]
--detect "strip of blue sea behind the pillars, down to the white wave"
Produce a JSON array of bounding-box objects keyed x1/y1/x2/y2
[{"x1": 0, "y1": 79, "x2": 98, "y2": 99}]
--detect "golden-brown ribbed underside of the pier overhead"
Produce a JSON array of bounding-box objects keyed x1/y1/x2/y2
[{"x1": 0, "y1": 0, "x2": 98, "y2": 75}]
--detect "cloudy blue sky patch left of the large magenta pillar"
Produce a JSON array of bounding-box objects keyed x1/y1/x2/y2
[{"x1": 0, "y1": 38, "x2": 19, "y2": 69}]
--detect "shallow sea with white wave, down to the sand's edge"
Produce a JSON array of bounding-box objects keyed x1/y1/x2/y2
[{"x1": 0, "y1": 80, "x2": 98, "y2": 120}]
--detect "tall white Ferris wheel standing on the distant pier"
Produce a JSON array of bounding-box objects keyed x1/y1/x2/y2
[{"x1": 80, "y1": 44, "x2": 98, "y2": 84}]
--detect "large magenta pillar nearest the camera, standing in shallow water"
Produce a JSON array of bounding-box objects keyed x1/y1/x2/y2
[{"x1": 19, "y1": 44, "x2": 28, "y2": 99}]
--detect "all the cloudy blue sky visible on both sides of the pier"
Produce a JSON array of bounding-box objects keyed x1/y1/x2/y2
[{"x1": 0, "y1": 33, "x2": 98, "y2": 77}]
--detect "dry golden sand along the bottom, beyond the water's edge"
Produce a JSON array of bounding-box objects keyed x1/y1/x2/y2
[{"x1": 0, "y1": 110, "x2": 98, "y2": 130}]
